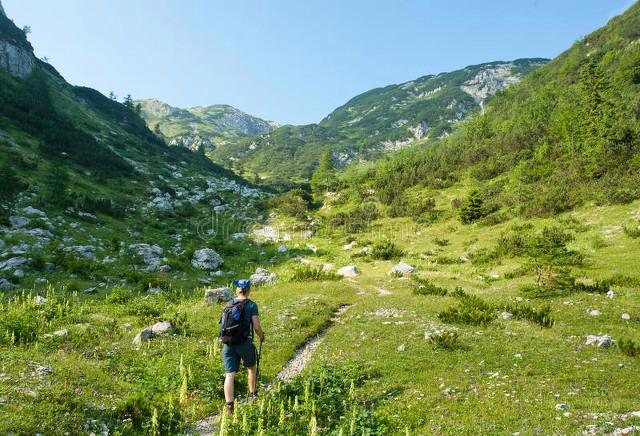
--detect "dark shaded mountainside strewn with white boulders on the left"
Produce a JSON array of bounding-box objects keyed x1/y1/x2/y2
[{"x1": 0, "y1": 5, "x2": 266, "y2": 293}]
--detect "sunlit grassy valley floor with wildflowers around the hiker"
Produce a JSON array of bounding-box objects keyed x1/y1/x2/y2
[{"x1": 0, "y1": 202, "x2": 640, "y2": 434}]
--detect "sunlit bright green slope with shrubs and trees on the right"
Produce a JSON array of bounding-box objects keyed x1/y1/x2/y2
[{"x1": 354, "y1": 4, "x2": 640, "y2": 214}]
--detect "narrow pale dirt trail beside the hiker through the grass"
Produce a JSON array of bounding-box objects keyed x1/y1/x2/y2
[{"x1": 189, "y1": 305, "x2": 351, "y2": 436}]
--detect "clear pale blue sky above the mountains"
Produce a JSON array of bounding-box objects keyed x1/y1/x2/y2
[{"x1": 2, "y1": 0, "x2": 633, "y2": 124}]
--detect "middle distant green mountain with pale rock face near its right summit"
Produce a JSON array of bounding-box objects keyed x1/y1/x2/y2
[{"x1": 206, "y1": 59, "x2": 547, "y2": 184}]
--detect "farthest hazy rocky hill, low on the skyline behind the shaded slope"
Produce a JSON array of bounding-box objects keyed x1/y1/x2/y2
[{"x1": 136, "y1": 99, "x2": 279, "y2": 150}]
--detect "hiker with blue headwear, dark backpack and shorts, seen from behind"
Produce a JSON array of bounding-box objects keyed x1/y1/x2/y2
[{"x1": 220, "y1": 280, "x2": 264, "y2": 413}]
